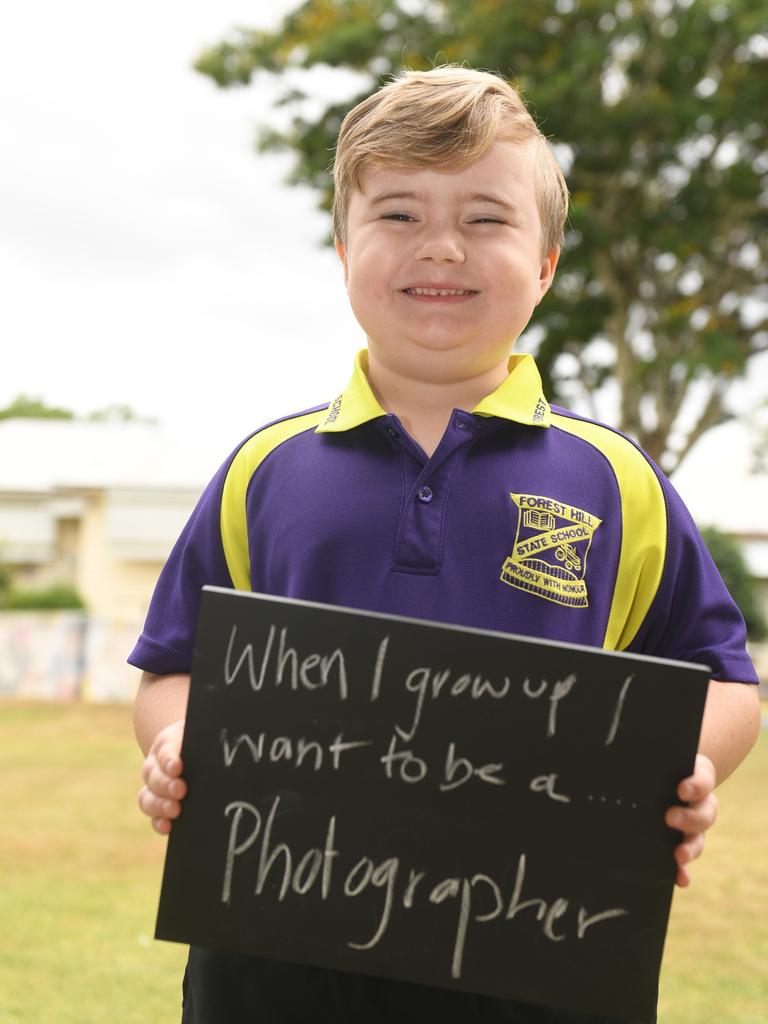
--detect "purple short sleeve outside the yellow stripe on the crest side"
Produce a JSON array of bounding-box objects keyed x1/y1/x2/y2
[{"x1": 627, "y1": 467, "x2": 758, "y2": 683}]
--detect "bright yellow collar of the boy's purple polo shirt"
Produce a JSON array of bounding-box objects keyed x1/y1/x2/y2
[{"x1": 316, "y1": 348, "x2": 550, "y2": 433}]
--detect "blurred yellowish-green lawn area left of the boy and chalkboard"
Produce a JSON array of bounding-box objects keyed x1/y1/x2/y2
[{"x1": 0, "y1": 701, "x2": 184, "y2": 1024}]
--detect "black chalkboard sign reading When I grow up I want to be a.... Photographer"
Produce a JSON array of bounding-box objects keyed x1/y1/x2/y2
[{"x1": 157, "y1": 588, "x2": 709, "y2": 1020}]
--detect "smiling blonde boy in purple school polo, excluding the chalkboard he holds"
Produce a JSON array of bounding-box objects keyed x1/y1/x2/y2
[{"x1": 130, "y1": 68, "x2": 758, "y2": 1024}]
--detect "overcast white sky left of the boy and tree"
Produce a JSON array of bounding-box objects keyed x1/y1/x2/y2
[{"x1": 0, "y1": 0, "x2": 370, "y2": 453}]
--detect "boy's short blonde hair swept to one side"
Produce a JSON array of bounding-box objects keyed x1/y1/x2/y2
[{"x1": 333, "y1": 65, "x2": 568, "y2": 256}]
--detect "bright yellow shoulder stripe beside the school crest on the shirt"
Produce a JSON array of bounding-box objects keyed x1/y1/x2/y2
[{"x1": 552, "y1": 413, "x2": 667, "y2": 650}]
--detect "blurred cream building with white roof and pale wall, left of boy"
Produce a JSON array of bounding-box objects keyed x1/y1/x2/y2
[{"x1": 0, "y1": 419, "x2": 220, "y2": 699}]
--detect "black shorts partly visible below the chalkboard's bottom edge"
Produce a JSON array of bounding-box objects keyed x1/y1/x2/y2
[{"x1": 181, "y1": 946, "x2": 655, "y2": 1024}]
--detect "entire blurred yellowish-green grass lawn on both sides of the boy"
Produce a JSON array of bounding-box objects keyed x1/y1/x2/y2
[{"x1": 0, "y1": 700, "x2": 768, "y2": 1024}]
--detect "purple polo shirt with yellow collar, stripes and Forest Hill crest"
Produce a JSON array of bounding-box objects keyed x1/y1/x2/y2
[{"x1": 129, "y1": 351, "x2": 757, "y2": 682}]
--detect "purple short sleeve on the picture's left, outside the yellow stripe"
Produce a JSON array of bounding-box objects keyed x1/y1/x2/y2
[{"x1": 128, "y1": 456, "x2": 239, "y2": 676}]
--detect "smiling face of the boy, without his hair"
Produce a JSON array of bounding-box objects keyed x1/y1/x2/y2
[{"x1": 336, "y1": 140, "x2": 559, "y2": 383}]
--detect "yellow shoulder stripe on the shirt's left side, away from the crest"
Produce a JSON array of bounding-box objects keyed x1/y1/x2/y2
[{"x1": 220, "y1": 409, "x2": 328, "y2": 590}]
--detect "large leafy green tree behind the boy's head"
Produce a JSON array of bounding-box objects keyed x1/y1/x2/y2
[{"x1": 196, "y1": 0, "x2": 768, "y2": 472}]
